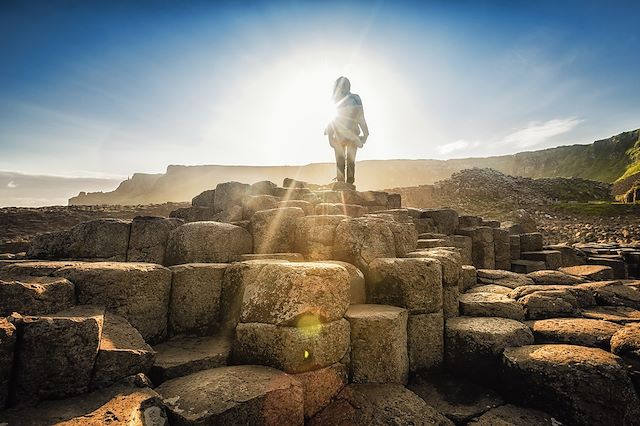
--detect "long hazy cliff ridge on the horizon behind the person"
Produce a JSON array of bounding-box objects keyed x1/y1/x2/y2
[{"x1": 69, "y1": 129, "x2": 640, "y2": 205}]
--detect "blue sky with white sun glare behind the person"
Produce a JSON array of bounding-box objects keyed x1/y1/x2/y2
[{"x1": 0, "y1": 0, "x2": 640, "y2": 176}]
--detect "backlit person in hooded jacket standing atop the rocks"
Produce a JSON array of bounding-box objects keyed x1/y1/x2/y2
[{"x1": 325, "y1": 77, "x2": 369, "y2": 185}]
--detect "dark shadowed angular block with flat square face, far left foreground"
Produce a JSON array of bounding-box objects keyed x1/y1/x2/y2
[{"x1": 11, "y1": 306, "x2": 104, "y2": 405}]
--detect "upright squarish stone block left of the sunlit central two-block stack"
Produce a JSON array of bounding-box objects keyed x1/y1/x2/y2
[{"x1": 169, "y1": 263, "x2": 228, "y2": 335}]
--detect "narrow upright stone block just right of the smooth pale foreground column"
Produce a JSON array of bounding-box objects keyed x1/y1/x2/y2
[{"x1": 407, "y1": 312, "x2": 444, "y2": 371}]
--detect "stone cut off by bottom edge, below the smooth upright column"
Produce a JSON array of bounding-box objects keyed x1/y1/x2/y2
[{"x1": 309, "y1": 384, "x2": 453, "y2": 426}]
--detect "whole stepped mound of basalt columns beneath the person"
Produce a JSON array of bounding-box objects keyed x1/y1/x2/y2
[{"x1": 0, "y1": 176, "x2": 640, "y2": 426}]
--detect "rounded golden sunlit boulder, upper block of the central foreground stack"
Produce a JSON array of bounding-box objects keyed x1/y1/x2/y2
[{"x1": 240, "y1": 262, "x2": 350, "y2": 326}]
